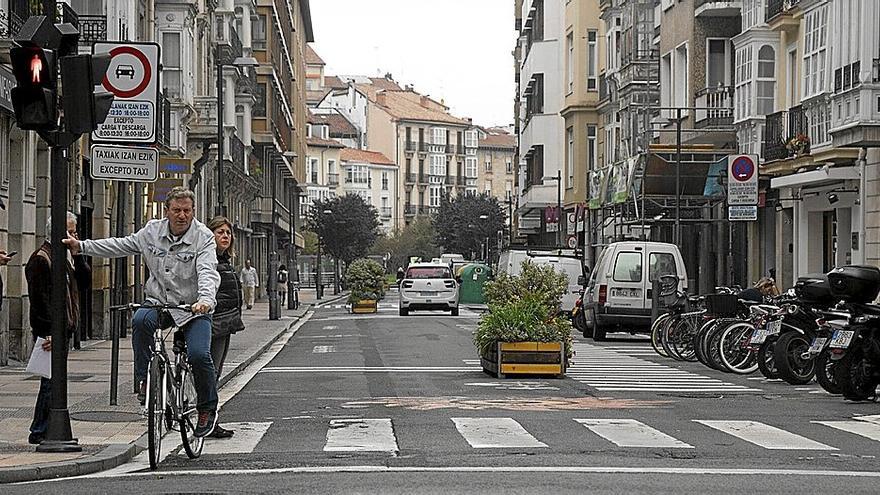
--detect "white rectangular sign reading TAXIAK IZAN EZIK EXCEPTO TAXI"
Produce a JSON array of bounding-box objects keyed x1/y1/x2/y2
[{"x1": 92, "y1": 144, "x2": 159, "y2": 182}]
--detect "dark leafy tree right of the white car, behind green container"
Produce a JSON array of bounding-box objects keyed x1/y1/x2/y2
[{"x1": 432, "y1": 193, "x2": 507, "y2": 258}]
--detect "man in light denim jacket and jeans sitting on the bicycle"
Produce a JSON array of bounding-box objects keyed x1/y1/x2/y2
[{"x1": 64, "y1": 187, "x2": 220, "y2": 437}]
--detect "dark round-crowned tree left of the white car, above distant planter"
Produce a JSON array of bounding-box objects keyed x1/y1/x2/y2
[{"x1": 307, "y1": 194, "x2": 379, "y2": 265}]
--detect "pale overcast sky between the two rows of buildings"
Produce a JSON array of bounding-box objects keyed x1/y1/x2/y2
[{"x1": 309, "y1": 0, "x2": 516, "y2": 126}]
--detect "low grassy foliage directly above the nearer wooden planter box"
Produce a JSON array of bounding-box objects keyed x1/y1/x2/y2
[{"x1": 474, "y1": 297, "x2": 572, "y2": 356}]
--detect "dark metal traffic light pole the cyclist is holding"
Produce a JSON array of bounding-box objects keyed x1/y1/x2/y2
[{"x1": 37, "y1": 142, "x2": 82, "y2": 452}]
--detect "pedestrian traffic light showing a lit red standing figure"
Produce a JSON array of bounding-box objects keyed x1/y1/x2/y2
[{"x1": 9, "y1": 46, "x2": 57, "y2": 131}]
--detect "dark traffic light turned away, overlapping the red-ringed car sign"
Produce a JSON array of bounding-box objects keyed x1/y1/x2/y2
[{"x1": 61, "y1": 53, "x2": 113, "y2": 134}]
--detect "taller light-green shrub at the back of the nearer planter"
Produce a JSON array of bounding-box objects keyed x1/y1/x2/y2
[{"x1": 483, "y1": 260, "x2": 568, "y2": 311}]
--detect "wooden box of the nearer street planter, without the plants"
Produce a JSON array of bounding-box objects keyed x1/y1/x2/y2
[{"x1": 480, "y1": 342, "x2": 565, "y2": 378}]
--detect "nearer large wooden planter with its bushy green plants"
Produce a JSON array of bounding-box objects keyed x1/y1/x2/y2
[{"x1": 474, "y1": 261, "x2": 572, "y2": 378}]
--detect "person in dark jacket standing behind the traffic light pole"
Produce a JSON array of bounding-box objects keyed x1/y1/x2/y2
[{"x1": 24, "y1": 212, "x2": 92, "y2": 444}]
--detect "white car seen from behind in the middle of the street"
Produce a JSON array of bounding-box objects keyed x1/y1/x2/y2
[{"x1": 399, "y1": 263, "x2": 458, "y2": 316}]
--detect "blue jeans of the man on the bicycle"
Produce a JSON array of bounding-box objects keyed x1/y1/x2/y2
[{"x1": 131, "y1": 308, "x2": 217, "y2": 411}]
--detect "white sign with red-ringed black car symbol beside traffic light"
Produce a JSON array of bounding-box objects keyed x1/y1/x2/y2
[{"x1": 92, "y1": 42, "x2": 159, "y2": 143}]
